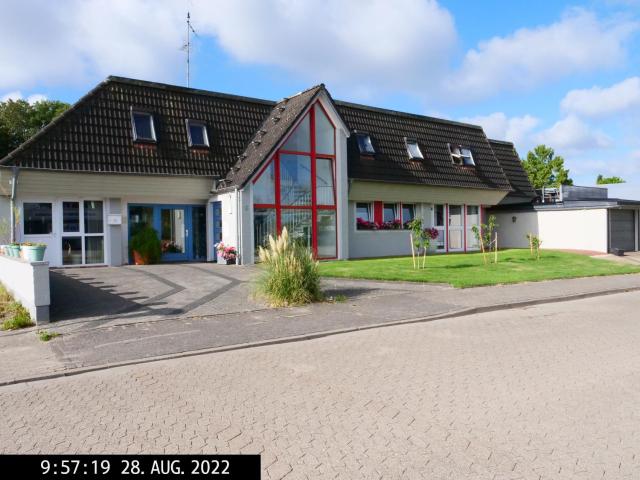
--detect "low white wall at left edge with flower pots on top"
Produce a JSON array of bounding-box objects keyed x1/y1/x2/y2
[{"x1": 0, "y1": 255, "x2": 51, "y2": 324}]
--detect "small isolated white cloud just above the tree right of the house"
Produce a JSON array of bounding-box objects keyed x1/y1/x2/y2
[{"x1": 534, "y1": 115, "x2": 613, "y2": 153}]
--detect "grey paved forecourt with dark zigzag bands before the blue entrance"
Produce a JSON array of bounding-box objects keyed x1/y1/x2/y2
[{"x1": 51, "y1": 263, "x2": 262, "y2": 325}]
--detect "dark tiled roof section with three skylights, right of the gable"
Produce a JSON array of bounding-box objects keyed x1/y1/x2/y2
[{"x1": 335, "y1": 101, "x2": 510, "y2": 190}]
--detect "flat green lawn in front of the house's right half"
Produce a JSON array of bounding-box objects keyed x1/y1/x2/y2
[{"x1": 320, "y1": 249, "x2": 640, "y2": 288}]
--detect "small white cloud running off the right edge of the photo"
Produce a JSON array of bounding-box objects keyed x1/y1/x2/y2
[{"x1": 561, "y1": 77, "x2": 640, "y2": 117}]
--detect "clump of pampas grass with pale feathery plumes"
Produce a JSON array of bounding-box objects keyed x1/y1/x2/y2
[{"x1": 258, "y1": 228, "x2": 323, "y2": 307}]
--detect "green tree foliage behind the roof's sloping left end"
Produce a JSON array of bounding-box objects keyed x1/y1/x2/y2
[{"x1": 0, "y1": 100, "x2": 70, "y2": 158}]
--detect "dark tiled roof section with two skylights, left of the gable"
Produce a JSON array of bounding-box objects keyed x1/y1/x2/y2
[{"x1": 1, "y1": 77, "x2": 273, "y2": 178}]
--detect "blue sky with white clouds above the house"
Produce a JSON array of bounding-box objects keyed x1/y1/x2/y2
[{"x1": 0, "y1": 0, "x2": 640, "y2": 194}]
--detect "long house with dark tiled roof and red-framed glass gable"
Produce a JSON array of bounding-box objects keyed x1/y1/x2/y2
[{"x1": 0, "y1": 77, "x2": 520, "y2": 266}]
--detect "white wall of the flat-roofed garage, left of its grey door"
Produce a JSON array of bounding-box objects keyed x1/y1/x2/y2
[{"x1": 496, "y1": 208, "x2": 608, "y2": 253}]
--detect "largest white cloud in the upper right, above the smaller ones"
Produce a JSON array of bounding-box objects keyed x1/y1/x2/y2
[{"x1": 448, "y1": 9, "x2": 638, "y2": 98}]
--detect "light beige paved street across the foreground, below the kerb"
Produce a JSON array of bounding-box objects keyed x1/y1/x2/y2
[{"x1": 0, "y1": 292, "x2": 640, "y2": 480}]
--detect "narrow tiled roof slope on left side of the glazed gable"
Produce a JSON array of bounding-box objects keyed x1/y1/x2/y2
[{"x1": 225, "y1": 84, "x2": 325, "y2": 185}]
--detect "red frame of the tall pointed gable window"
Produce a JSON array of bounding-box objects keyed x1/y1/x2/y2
[{"x1": 253, "y1": 101, "x2": 338, "y2": 260}]
